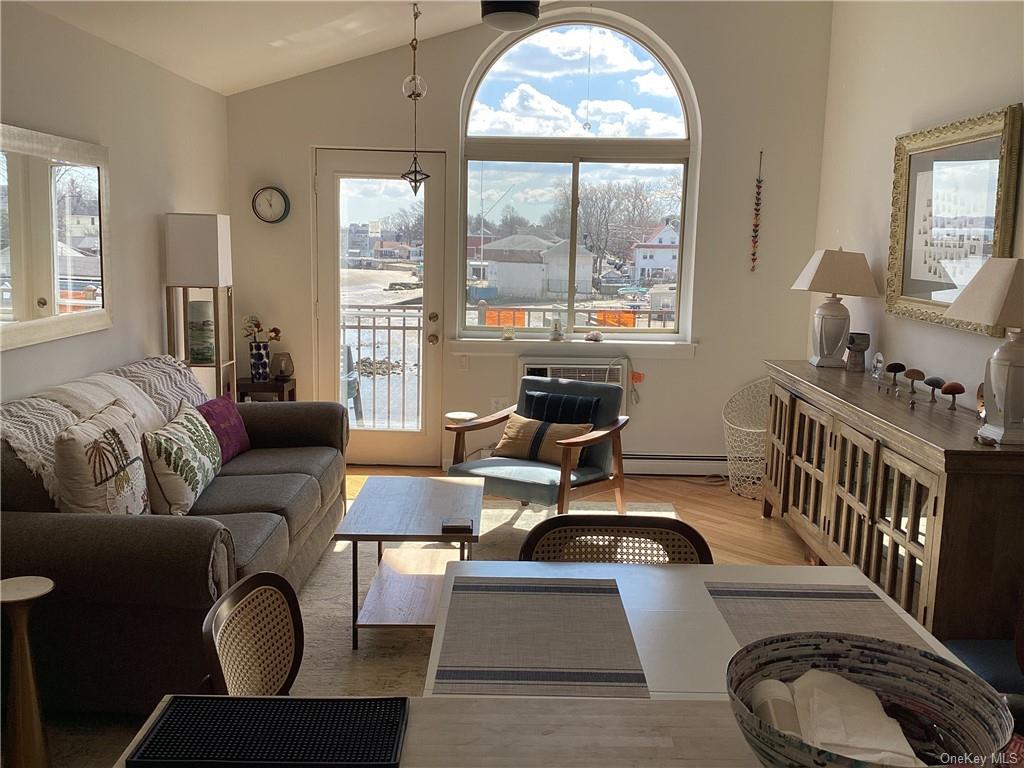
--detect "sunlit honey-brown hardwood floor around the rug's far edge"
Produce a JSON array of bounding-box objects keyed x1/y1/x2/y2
[{"x1": 347, "y1": 466, "x2": 806, "y2": 565}]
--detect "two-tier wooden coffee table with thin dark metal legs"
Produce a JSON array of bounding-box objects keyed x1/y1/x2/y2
[{"x1": 334, "y1": 476, "x2": 483, "y2": 648}]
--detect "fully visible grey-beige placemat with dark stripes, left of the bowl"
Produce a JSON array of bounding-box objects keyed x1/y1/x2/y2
[{"x1": 433, "y1": 577, "x2": 650, "y2": 698}]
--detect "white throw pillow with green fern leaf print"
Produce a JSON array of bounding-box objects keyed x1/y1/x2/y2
[{"x1": 142, "y1": 400, "x2": 220, "y2": 515}]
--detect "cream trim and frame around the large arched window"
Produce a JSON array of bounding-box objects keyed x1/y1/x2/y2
[{"x1": 455, "y1": 7, "x2": 700, "y2": 343}]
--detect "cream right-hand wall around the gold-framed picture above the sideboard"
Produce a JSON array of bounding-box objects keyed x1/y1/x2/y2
[{"x1": 812, "y1": 2, "x2": 1024, "y2": 392}]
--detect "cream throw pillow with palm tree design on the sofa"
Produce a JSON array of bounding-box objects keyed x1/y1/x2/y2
[{"x1": 53, "y1": 399, "x2": 150, "y2": 515}]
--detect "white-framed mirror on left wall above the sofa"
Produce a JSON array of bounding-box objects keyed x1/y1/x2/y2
[{"x1": 0, "y1": 125, "x2": 111, "y2": 349}]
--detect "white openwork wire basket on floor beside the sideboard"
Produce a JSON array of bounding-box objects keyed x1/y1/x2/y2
[{"x1": 722, "y1": 377, "x2": 771, "y2": 499}]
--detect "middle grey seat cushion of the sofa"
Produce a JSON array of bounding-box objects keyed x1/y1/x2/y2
[{"x1": 190, "y1": 473, "x2": 321, "y2": 540}]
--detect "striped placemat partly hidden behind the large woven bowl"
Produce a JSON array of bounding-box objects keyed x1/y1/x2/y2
[{"x1": 705, "y1": 582, "x2": 930, "y2": 650}]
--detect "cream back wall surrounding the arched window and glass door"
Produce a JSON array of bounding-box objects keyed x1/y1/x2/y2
[{"x1": 228, "y1": 2, "x2": 831, "y2": 462}]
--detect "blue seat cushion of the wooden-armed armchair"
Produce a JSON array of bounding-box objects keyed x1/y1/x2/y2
[{"x1": 449, "y1": 457, "x2": 607, "y2": 507}]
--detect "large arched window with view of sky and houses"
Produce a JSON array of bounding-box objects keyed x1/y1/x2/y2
[{"x1": 462, "y1": 23, "x2": 690, "y2": 335}]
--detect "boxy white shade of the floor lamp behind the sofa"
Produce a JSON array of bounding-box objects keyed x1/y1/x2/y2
[{"x1": 165, "y1": 213, "x2": 231, "y2": 288}]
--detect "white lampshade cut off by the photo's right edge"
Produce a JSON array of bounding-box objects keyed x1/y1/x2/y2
[{"x1": 946, "y1": 258, "x2": 1024, "y2": 328}]
